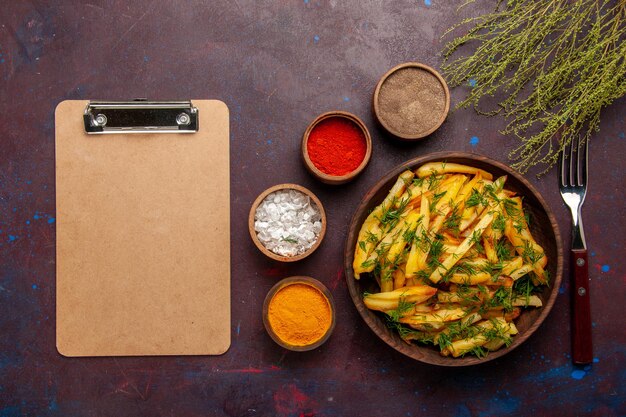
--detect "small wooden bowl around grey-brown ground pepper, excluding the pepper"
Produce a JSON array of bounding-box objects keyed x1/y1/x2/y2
[{"x1": 373, "y1": 62, "x2": 450, "y2": 141}]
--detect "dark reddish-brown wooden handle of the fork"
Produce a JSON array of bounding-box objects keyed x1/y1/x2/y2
[{"x1": 570, "y1": 249, "x2": 593, "y2": 364}]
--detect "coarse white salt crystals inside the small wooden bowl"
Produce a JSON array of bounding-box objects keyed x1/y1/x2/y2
[{"x1": 254, "y1": 190, "x2": 322, "y2": 256}]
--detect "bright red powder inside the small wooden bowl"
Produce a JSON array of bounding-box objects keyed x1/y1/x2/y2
[{"x1": 307, "y1": 117, "x2": 367, "y2": 176}]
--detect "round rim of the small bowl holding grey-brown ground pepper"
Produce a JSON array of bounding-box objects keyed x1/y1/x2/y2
[{"x1": 372, "y1": 62, "x2": 450, "y2": 142}]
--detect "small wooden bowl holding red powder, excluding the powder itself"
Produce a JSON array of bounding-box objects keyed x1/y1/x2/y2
[{"x1": 301, "y1": 110, "x2": 372, "y2": 185}]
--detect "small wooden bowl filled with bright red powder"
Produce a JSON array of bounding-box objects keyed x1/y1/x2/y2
[{"x1": 302, "y1": 111, "x2": 372, "y2": 184}]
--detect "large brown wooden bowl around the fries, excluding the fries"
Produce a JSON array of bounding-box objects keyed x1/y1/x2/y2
[{"x1": 344, "y1": 152, "x2": 563, "y2": 366}]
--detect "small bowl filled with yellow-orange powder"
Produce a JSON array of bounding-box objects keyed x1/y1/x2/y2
[{"x1": 263, "y1": 276, "x2": 335, "y2": 352}]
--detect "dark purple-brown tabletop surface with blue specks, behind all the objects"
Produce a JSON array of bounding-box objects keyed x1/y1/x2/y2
[{"x1": 0, "y1": 0, "x2": 626, "y2": 417}]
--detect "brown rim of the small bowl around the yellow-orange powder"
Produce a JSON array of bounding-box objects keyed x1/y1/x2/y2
[{"x1": 263, "y1": 275, "x2": 337, "y2": 352}]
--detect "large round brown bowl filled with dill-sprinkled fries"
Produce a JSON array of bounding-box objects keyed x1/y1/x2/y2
[{"x1": 345, "y1": 152, "x2": 563, "y2": 366}]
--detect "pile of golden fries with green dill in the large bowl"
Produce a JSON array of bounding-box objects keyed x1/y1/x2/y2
[{"x1": 353, "y1": 162, "x2": 548, "y2": 357}]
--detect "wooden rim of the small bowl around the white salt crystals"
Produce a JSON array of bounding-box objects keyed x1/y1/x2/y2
[{"x1": 248, "y1": 184, "x2": 326, "y2": 262}]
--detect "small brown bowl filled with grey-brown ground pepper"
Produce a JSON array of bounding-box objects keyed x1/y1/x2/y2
[{"x1": 373, "y1": 62, "x2": 450, "y2": 141}]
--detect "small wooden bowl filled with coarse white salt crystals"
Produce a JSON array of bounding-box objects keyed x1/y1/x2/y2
[{"x1": 248, "y1": 184, "x2": 326, "y2": 262}]
